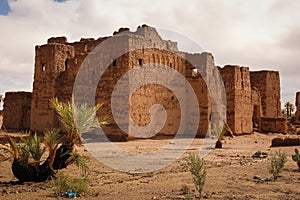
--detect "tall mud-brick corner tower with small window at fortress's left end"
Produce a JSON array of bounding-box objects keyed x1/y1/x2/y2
[{"x1": 30, "y1": 43, "x2": 74, "y2": 132}]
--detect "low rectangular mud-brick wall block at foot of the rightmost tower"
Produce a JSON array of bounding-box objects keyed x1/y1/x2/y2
[{"x1": 261, "y1": 117, "x2": 288, "y2": 133}]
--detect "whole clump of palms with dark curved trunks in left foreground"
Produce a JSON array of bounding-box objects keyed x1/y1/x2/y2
[{"x1": 0, "y1": 98, "x2": 107, "y2": 182}]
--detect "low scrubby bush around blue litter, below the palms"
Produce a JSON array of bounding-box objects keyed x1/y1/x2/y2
[{"x1": 51, "y1": 172, "x2": 89, "y2": 196}]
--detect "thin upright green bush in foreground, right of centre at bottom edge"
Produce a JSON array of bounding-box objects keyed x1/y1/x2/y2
[{"x1": 189, "y1": 154, "x2": 206, "y2": 198}]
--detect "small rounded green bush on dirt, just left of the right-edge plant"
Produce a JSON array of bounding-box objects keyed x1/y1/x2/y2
[{"x1": 268, "y1": 150, "x2": 287, "y2": 180}]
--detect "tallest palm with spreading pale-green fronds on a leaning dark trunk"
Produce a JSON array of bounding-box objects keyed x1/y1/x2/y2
[{"x1": 50, "y1": 97, "x2": 108, "y2": 170}]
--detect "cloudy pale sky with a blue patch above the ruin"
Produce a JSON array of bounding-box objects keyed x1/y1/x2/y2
[{"x1": 0, "y1": 0, "x2": 300, "y2": 108}]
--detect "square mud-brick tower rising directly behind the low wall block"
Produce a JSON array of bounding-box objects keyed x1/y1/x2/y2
[{"x1": 250, "y1": 71, "x2": 281, "y2": 118}]
